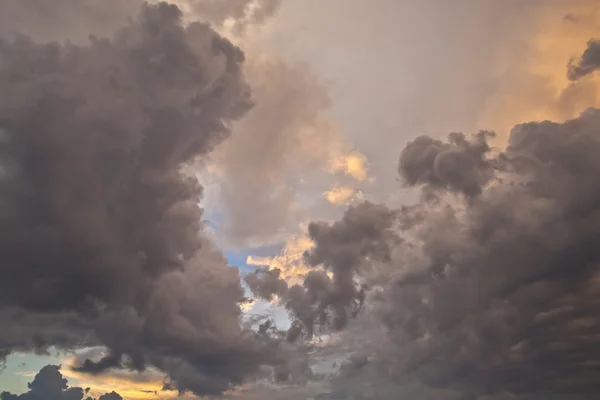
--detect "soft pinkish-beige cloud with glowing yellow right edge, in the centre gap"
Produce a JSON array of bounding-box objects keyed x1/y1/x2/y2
[{"x1": 206, "y1": 57, "x2": 366, "y2": 247}]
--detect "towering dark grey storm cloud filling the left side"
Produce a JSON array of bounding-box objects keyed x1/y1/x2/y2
[{"x1": 0, "y1": 3, "x2": 288, "y2": 394}]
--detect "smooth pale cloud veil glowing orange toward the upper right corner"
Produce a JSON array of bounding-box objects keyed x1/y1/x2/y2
[{"x1": 268, "y1": 0, "x2": 600, "y2": 212}]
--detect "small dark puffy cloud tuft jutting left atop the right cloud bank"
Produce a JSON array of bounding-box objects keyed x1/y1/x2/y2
[{"x1": 398, "y1": 131, "x2": 494, "y2": 197}]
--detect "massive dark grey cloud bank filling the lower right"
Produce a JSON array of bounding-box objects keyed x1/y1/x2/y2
[{"x1": 294, "y1": 109, "x2": 600, "y2": 398}]
